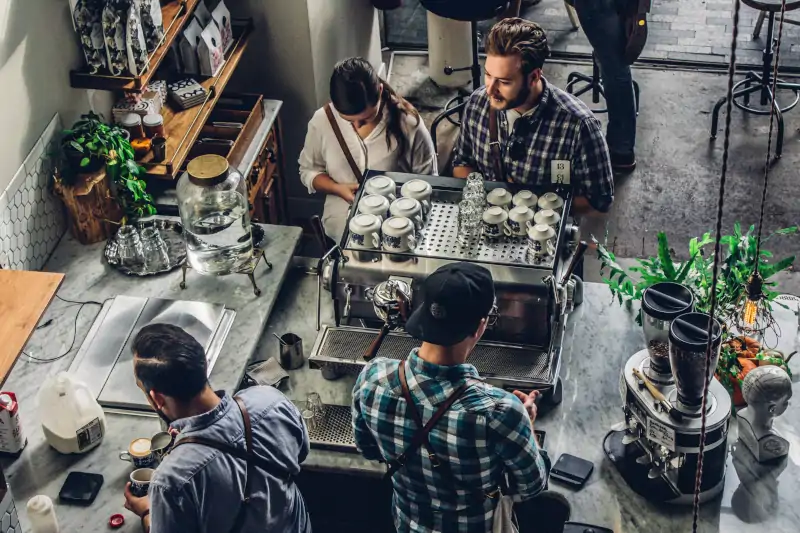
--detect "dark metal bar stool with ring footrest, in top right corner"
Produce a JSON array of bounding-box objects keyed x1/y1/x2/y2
[{"x1": 711, "y1": 0, "x2": 800, "y2": 159}]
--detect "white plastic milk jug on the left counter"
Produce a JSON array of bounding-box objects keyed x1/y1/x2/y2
[{"x1": 39, "y1": 372, "x2": 106, "y2": 453}]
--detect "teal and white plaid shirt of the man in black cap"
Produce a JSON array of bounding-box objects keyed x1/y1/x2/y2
[{"x1": 353, "y1": 350, "x2": 549, "y2": 533}]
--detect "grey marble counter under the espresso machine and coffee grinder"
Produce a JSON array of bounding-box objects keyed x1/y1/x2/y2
[{"x1": 262, "y1": 275, "x2": 800, "y2": 533}]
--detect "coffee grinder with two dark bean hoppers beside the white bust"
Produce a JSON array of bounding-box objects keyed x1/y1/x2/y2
[{"x1": 603, "y1": 283, "x2": 731, "y2": 504}]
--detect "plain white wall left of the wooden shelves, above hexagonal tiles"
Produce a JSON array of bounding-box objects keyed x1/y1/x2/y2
[{"x1": 0, "y1": 0, "x2": 89, "y2": 192}]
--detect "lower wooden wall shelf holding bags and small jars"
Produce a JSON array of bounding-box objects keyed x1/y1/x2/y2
[{"x1": 138, "y1": 20, "x2": 253, "y2": 180}]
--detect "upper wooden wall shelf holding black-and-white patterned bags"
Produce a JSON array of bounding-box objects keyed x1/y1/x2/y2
[{"x1": 69, "y1": 0, "x2": 200, "y2": 91}]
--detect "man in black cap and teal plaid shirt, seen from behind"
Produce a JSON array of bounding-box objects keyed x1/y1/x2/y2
[{"x1": 353, "y1": 263, "x2": 568, "y2": 533}]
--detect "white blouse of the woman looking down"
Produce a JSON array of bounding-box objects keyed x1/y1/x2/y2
[{"x1": 299, "y1": 103, "x2": 438, "y2": 243}]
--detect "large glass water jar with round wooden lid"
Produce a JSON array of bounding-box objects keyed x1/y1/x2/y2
[{"x1": 177, "y1": 154, "x2": 253, "y2": 276}]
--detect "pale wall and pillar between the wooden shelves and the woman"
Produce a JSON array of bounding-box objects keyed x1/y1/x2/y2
[{"x1": 231, "y1": 0, "x2": 381, "y2": 218}]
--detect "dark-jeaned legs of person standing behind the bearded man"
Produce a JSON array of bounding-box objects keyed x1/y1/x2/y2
[{"x1": 575, "y1": 0, "x2": 636, "y2": 173}]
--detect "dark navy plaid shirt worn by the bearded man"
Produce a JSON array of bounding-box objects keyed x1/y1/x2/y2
[{"x1": 453, "y1": 78, "x2": 614, "y2": 212}]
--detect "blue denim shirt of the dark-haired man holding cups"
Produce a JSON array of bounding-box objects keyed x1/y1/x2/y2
[{"x1": 150, "y1": 387, "x2": 311, "y2": 533}]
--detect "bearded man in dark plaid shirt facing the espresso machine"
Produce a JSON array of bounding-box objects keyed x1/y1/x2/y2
[{"x1": 453, "y1": 18, "x2": 614, "y2": 215}]
